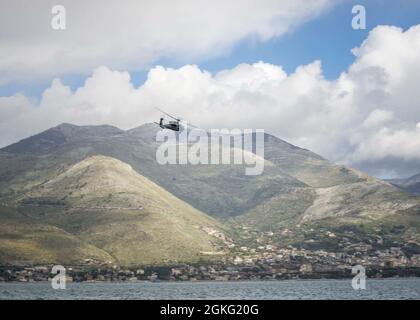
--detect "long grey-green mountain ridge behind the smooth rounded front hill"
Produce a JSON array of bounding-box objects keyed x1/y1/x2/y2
[{"x1": 0, "y1": 124, "x2": 417, "y2": 225}]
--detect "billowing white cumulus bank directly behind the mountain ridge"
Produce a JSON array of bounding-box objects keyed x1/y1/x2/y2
[{"x1": 0, "y1": 26, "x2": 420, "y2": 179}]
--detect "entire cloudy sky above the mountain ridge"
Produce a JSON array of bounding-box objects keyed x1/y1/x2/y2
[{"x1": 0, "y1": 0, "x2": 420, "y2": 178}]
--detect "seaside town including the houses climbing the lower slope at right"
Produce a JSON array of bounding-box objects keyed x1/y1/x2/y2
[{"x1": 0, "y1": 225, "x2": 420, "y2": 282}]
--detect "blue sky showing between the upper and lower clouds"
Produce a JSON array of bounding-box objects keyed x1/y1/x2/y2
[{"x1": 0, "y1": 0, "x2": 420, "y2": 97}]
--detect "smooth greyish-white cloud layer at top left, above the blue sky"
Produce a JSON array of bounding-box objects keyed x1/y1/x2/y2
[{"x1": 0, "y1": 0, "x2": 333, "y2": 84}]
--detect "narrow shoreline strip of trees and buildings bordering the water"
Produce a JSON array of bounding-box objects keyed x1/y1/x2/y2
[{"x1": 0, "y1": 263, "x2": 420, "y2": 283}]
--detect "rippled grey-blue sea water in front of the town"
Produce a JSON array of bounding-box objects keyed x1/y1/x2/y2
[{"x1": 0, "y1": 278, "x2": 420, "y2": 300}]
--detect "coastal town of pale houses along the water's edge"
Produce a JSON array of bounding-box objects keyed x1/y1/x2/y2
[{"x1": 0, "y1": 244, "x2": 420, "y2": 282}]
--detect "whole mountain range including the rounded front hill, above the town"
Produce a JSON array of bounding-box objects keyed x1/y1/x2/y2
[{"x1": 0, "y1": 124, "x2": 420, "y2": 263}]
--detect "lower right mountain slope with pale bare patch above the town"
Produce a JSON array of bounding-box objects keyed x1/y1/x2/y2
[{"x1": 239, "y1": 171, "x2": 419, "y2": 230}]
